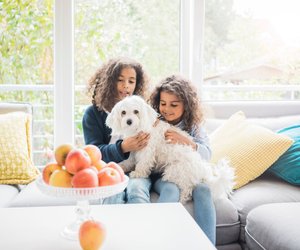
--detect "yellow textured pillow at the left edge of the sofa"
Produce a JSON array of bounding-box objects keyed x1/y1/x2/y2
[{"x1": 0, "y1": 112, "x2": 39, "y2": 184}]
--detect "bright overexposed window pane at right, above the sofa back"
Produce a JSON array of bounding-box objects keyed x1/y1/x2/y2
[{"x1": 203, "y1": 0, "x2": 300, "y2": 100}]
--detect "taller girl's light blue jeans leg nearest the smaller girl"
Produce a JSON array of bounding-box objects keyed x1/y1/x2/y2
[{"x1": 126, "y1": 178, "x2": 151, "y2": 203}]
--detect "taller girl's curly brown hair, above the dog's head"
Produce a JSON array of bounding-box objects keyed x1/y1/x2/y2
[{"x1": 88, "y1": 57, "x2": 148, "y2": 112}]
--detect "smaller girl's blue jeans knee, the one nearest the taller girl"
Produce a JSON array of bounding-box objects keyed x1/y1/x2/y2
[{"x1": 154, "y1": 178, "x2": 180, "y2": 203}]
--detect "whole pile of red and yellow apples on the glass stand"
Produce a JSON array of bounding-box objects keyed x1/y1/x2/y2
[{"x1": 42, "y1": 144, "x2": 125, "y2": 188}]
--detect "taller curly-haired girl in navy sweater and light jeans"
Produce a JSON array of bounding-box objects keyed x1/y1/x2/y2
[{"x1": 82, "y1": 58, "x2": 149, "y2": 203}]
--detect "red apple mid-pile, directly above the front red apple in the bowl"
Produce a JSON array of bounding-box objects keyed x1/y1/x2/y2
[{"x1": 65, "y1": 148, "x2": 91, "y2": 174}]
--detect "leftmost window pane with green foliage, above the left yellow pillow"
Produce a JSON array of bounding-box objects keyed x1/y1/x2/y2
[{"x1": 0, "y1": 0, "x2": 54, "y2": 165}]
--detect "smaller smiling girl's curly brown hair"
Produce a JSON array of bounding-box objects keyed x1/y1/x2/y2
[{"x1": 150, "y1": 75, "x2": 203, "y2": 132}]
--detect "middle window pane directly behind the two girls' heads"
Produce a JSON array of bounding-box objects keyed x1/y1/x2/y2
[{"x1": 74, "y1": 0, "x2": 180, "y2": 145}]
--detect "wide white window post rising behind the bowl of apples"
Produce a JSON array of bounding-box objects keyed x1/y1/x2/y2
[{"x1": 54, "y1": 0, "x2": 74, "y2": 146}]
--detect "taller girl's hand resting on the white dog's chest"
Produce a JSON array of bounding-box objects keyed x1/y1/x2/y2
[{"x1": 121, "y1": 132, "x2": 150, "y2": 153}]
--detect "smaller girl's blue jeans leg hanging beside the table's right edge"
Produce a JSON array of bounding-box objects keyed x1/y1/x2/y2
[{"x1": 193, "y1": 183, "x2": 216, "y2": 245}]
